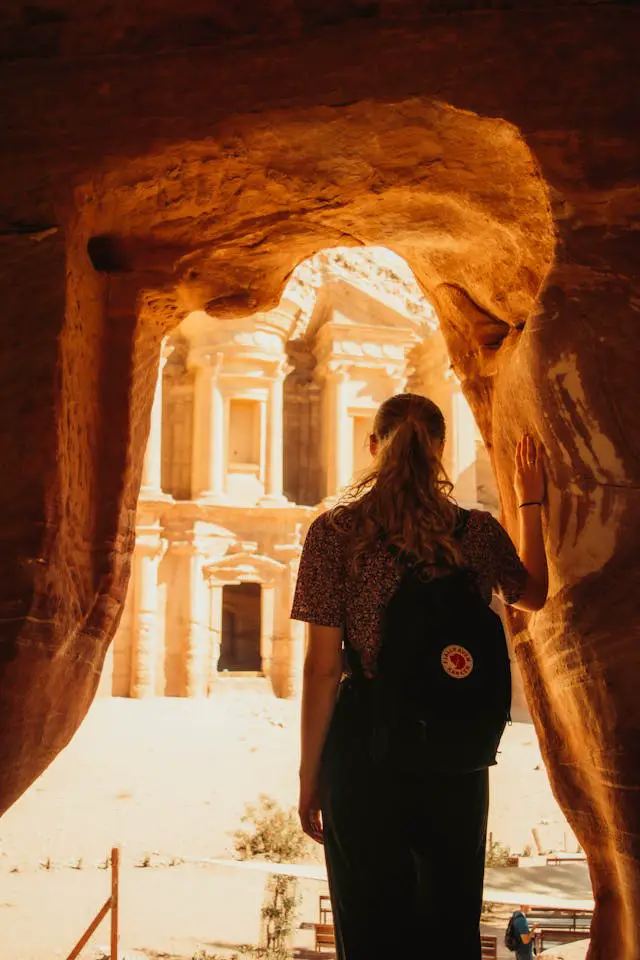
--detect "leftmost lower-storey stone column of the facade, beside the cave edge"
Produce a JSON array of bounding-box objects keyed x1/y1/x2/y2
[{"x1": 131, "y1": 523, "x2": 164, "y2": 698}]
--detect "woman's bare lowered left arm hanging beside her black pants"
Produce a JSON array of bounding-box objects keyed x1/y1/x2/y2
[{"x1": 299, "y1": 623, "x2": 342, "y2": 843}]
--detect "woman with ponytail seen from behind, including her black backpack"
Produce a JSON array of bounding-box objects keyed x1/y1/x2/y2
[{"x1": 292, "y1": 393, "x2": 547, "y2": 960}]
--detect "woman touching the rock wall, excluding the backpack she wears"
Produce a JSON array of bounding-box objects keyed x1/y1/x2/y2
[{"x1": 292, "y1": 393, "x2": 547, "y2": 960}]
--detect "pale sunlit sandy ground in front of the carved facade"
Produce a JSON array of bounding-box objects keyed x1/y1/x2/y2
[{"x1": 0, "y1": 681, "x2": 575, "y2": 960}]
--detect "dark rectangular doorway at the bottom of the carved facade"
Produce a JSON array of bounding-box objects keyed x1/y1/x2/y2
[{"x1": 218, "y1": 583, "x2": 262, "y2": 674}]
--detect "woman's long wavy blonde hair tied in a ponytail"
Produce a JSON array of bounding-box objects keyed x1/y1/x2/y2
[{"x1": 332, "y1": 393, "x2": 461, "y2": 572}]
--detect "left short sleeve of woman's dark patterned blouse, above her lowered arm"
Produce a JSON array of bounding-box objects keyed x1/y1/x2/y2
[{"x1": 291, "y1": 513, "x2": 345, "y2": 627}]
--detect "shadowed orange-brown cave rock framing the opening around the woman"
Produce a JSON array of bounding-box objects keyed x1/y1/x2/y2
[{"x1": 0, "y1": 0, "x2": 640, "y2": 960}]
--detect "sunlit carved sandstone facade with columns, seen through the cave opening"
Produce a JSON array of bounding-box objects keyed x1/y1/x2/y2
[{"x1": 101, "y1": 280, "x2": 494, "y2": 697}]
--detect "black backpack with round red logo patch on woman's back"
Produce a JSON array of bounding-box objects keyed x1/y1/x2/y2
[{"x1": 352, "y1": 511, "x2": 511, "y2": 773}]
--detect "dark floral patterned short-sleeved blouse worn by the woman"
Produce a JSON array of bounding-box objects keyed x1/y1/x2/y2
[{"x1": 291, "y1": 510, "x2": 527, "y2": 677}]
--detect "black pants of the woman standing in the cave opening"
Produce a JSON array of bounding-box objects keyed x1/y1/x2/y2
[{"x1": 322, "y1": 688, "x2": 489, "y2": 960}]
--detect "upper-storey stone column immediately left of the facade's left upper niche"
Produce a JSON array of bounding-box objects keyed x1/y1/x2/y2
[{"x1": 192, "y1": 353, "x2": 225, "y2": 501}]
